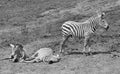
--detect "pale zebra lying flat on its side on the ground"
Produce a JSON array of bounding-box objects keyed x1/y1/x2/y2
[{"x1": 21, "y1": 48, "x2": 60, "y2": 63}]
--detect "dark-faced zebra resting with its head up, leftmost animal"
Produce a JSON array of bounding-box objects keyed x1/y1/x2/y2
[{"x1": 9, "y1": 43, "x2": 29, "y2": 62}]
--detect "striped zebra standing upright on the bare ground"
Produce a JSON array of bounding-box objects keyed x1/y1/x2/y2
[{"x1": 60, "y1": 12, "x2": 109, "y2": 53}]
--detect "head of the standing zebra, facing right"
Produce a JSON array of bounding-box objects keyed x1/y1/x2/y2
[{"x1": 97, "y1": 12, "x2": 109, "y2": 30}]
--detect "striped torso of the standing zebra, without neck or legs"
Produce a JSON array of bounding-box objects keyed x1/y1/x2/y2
[{"x1": 62, "y1": 21, "x2": 91, "y2": 37}]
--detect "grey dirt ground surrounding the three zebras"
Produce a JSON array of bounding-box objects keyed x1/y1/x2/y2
[{"x1": 0, "y1": 0, "x2": 120, "y2": 74}]
